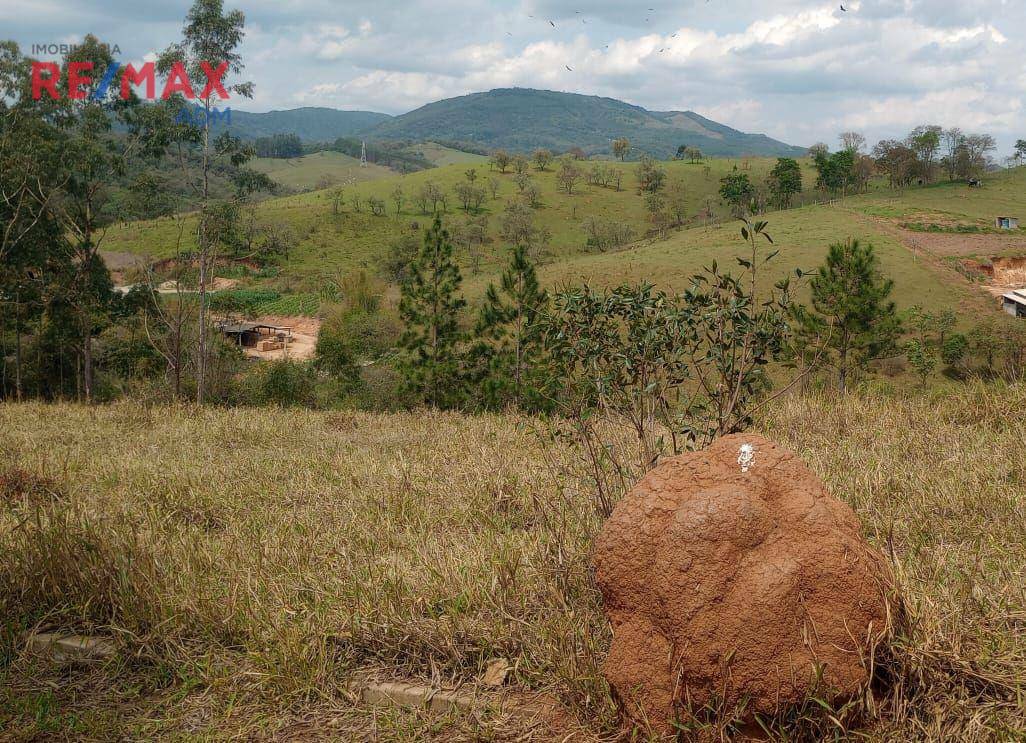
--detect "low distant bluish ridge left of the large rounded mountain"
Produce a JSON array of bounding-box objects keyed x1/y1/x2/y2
[{"x1": 222, "y1": 108, "x2": 392, "y2": 142}]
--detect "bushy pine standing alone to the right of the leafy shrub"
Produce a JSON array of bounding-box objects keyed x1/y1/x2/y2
[{"x1": 797, "y1": 240, "x2": 902, "y2": 392}]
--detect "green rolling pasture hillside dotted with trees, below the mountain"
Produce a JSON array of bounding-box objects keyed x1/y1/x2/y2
[{"x1": 97, "y1": 159, "x2": 1026, "y2": 330}]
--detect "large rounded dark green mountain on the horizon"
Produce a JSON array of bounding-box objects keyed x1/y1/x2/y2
[{"x1": 362, "y1": 88, "x2": 805, "y2": 158}]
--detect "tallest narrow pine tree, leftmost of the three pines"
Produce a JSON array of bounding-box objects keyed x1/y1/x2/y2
[{"x1": 399, "y1": 217, "x2": 467, "y2": 407}]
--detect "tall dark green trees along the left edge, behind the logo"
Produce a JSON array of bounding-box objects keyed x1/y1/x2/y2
[{"x1": 0, "y1": 0, "x2": 280, "y2": 402}]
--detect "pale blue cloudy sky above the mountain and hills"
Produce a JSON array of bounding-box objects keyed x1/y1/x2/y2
[{"x1": 0, "y1": 0, "x2": 1026, "y2": 156}]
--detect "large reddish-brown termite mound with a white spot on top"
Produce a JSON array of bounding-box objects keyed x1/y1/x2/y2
[{"x1": 593, "y1": 434, "x2": 893, "y2": 734}]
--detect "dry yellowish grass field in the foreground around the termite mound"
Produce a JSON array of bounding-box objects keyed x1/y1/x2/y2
[{"x1": 0, "y1": 385, "x2": 1026, "y2": 741}]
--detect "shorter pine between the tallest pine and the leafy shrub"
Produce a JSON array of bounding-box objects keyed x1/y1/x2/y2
[{"x1": 473, "y1": 245, "x2": 549, "y2": 410}]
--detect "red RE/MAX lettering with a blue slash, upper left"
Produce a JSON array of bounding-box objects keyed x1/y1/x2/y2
[{"x1": 32, "y1": 62, "x2": 228, "y2": 101}]
